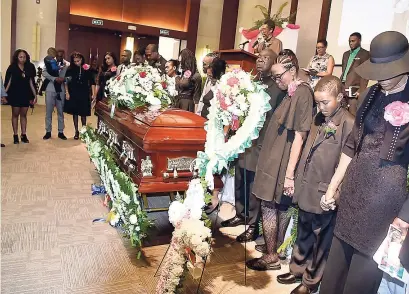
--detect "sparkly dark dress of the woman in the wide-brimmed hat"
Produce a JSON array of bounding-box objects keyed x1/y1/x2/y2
[{"x1": 335, "y1": 91, "x2": 409, "y2": 256}]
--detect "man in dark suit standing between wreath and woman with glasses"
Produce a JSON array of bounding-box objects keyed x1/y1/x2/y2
[{"x1": 221, "y1": 48, "x2": 285, "y2": 242}]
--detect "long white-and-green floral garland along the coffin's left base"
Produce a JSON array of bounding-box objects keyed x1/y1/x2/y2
[{"x1": 80, "y1": 126, "x2": 152, "y2": 258}]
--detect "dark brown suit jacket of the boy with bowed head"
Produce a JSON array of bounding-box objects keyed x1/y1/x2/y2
[{"x1": 293, "y1": 108, "x2": 354, "y2": 214}]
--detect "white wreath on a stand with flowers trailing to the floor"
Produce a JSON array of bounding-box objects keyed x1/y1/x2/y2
[{"x1": 156, "y1": 70, "x2": 271, "y2": 294}]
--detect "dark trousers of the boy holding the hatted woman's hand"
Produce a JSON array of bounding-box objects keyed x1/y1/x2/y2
[{"x1": 290, "y1": 209, "x2": 336, "y2": 290}]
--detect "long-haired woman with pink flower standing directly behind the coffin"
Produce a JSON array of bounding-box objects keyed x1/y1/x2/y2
[{"x1": 174, "y1": 49, "x2": 202, "y2": 112}]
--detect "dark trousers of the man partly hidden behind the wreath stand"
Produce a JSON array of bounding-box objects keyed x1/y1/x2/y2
[{"x1": 234, "y1": 164, "x2": 261, "y2": 225}]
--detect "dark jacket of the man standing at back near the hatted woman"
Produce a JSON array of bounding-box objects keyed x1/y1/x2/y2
[{"x1": 340, "y1": 48, "x2": 369, "y2": 93}]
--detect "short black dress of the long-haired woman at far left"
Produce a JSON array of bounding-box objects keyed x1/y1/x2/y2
[{"x1": 4, "y1": 64, "x2": 35, "y2": 107}]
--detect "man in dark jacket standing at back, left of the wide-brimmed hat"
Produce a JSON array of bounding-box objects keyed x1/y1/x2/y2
[{"x1": 340, "y1": 33, "x2": 369, "y2": 115}]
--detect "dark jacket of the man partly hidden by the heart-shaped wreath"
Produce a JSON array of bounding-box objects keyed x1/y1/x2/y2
[{"x1": 239, "y1": 77, "x2": 286, "y2": 172}]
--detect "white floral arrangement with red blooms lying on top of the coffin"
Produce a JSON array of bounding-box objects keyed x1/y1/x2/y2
[{"x1": 107, "y1": 64, "x2": 177, "y2": 110}]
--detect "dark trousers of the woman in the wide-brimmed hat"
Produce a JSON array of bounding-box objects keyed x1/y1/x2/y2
[{"x1": 320, "y1": 236, "x2": 382, "y2": 294}]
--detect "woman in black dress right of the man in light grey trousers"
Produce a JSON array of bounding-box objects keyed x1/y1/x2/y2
[{"x1": 64, "y1": 52, "x2": 95, "y2": 140}]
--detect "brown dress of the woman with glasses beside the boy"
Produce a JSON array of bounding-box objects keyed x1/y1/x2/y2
[{"x1": 252, "y1": 83, "x2": 313, "y2": 204}]
